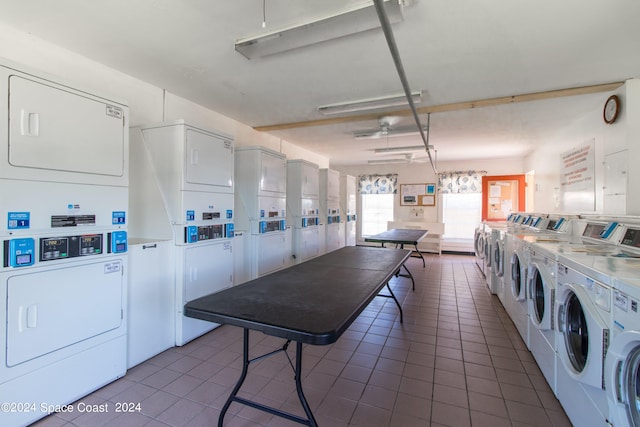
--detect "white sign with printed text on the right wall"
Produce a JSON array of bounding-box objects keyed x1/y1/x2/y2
[{"x1": 560, "y1": 139, "x2": 596, "y2": 212}]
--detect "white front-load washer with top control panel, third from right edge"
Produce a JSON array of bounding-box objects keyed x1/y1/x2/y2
[{"x1": 527, "y1": 221, "x2": 617, "y2": 393}]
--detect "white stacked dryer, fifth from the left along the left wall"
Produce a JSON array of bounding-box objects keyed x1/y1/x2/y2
[{"x1": 320, "y1": 169, "x2": 344, "y2": 252}]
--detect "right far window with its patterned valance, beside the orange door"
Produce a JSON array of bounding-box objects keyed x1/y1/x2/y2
[{"x1": 438, "y1": 171, "x2": 487, "y2": 240}]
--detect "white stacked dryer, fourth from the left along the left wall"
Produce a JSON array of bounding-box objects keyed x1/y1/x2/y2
[{"x1": 287, "y1": 160, "x2": 324, "y2": 264}]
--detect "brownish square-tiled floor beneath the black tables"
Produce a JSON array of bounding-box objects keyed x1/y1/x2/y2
[{"x1": 36, "y1": 255, "x2": 571, "y2": 427}]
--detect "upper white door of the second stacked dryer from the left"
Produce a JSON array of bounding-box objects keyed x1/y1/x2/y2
[{"x1": 185, "y1": 129, "x2": 233, "y2": 191}]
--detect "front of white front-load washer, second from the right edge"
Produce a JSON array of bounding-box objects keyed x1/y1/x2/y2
[{"x1": 555, "y1": 254, "x2": 612, "y2": 426}]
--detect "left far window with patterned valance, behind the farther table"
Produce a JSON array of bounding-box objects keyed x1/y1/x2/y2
[{"x1": 358, "y1": 174, "x2": 398, "y2": 237}]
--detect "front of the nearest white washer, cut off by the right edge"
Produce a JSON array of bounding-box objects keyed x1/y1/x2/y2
[{"x1": 605, "y1": 274, "x2": 640, "y2": 427}]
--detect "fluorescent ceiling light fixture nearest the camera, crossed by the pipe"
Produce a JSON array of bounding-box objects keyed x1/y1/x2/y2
[{"x1": 235, "y1": 0, "x2": 404, "y2": 59}]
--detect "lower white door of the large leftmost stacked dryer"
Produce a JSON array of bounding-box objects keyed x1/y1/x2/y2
[{"x1": 3, "y1": 260, "x2": 125, "y2": 366}]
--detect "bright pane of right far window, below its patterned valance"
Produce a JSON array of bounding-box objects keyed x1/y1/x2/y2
[{"x1": 442, "y1": 193, "x2": 482, "y2": 239}]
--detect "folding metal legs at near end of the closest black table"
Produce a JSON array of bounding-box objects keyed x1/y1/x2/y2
[{"x1": 218, "y1": 328, "x2": 318, "y2": 427}]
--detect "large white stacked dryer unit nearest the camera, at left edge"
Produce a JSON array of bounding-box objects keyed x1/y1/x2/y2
[{"x1": 0, "y1": 63, "x2": 129, "y2": 426}]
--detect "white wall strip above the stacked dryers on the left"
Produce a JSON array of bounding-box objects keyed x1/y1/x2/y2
[{"x1": 0, "y1": 24, "x2": 329, "y2": 167}]
